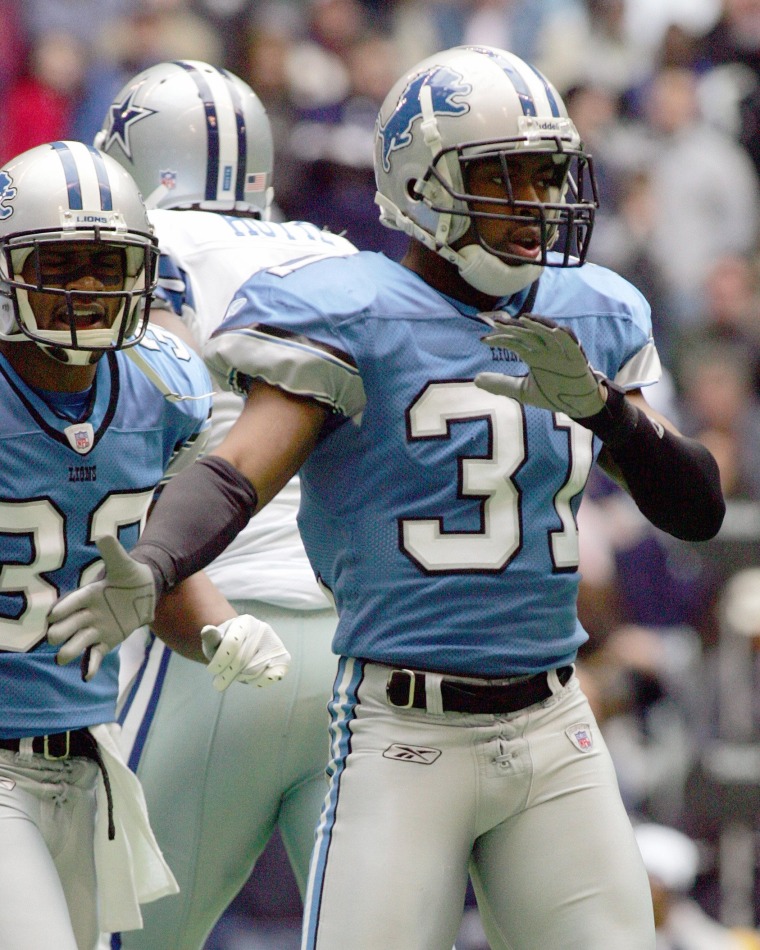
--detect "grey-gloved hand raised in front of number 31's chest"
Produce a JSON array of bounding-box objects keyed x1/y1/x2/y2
[{"x1": 475, "y1": 312, "x2": 605, "y2": 419}]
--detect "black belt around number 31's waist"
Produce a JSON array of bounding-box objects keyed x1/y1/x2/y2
[{"x1": 385, "y1": 666, "x2": 573, "y2": 714}]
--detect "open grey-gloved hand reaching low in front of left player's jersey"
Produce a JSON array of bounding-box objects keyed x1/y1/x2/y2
[{"x1": 47, "y1": 535, "x2": 156, "y2": 680}]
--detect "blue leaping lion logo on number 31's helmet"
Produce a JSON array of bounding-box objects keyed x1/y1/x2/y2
[{"x1": 378, "y1": 66, "x2": 472, "y2": 172}]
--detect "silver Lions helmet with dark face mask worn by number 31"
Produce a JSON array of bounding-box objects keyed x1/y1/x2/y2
[{"x1": 375, "y1": 46, "x2": 598, "y2": 297}]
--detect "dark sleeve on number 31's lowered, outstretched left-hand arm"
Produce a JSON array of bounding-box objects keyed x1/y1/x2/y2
[{"x1": 131, "y1": 455, "x2": 257, "y2": 597}]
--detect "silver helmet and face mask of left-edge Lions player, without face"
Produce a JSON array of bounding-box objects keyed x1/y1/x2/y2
[{"x1": 0, "y1": 142, "x2": 158, "y2": 365}]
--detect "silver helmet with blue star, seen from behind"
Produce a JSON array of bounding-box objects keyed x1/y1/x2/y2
[{"x1": 95, "y1": 60, "x2": 273, "y2": 219}]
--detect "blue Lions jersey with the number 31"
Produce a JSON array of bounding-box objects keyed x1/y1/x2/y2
[{"x1": 206, "y1": 253, "x2": 660, "y2": 677}]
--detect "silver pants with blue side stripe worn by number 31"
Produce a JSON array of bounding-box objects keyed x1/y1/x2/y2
[{"x1": 302, "y1": 658, "x2": 655, "y2": 950}]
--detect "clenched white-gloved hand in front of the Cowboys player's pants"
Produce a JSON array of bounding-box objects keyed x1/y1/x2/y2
[{"x1": 201, "y1": 614, "x2": 290, "y2": 692}]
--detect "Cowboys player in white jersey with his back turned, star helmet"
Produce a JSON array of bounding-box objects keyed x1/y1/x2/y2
[{"x1": 83, "y1": 60, "x2": 356, "y2": 950}]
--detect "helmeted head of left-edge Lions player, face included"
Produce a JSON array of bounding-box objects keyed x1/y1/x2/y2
[{"x1": 0, "y1": 142, "x2": 158, "y2": 365}]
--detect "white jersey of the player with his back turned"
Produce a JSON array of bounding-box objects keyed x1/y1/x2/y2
[{"x1": 150, "y1": 210, "x2": 356, "y2": 610}]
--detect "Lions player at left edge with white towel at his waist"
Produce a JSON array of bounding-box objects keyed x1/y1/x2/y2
[{"x1": 0, "y1": 142, "x2": 284, "y2": 950}]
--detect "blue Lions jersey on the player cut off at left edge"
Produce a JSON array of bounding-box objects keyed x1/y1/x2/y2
[{"x1": 0, "y1": 329, "x2": 211, "y2": 738}]
